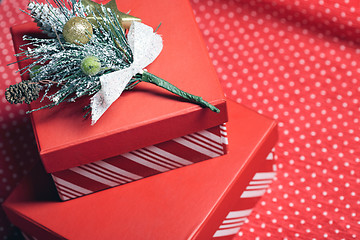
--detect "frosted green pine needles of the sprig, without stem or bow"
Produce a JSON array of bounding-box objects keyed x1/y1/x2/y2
[{"x1": 16, "y1": 0, "x2": 137, "y2": 111}]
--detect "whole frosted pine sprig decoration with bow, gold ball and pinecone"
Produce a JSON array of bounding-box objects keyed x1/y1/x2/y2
[{"x1": 7, "y1": 0, "x2": 219, "y2": 124}]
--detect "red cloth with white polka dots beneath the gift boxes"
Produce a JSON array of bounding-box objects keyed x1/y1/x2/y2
[{"x1": 0, "y1": 0, "x2": 360, "y2": 239}]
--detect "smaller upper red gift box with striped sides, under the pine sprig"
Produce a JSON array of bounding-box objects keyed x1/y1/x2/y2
[{"x1": 12, "y1": 0, "x2": 227, "y2": 200}]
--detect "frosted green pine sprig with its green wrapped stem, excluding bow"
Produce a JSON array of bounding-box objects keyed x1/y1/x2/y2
[{"x1": 8, "y1": 0, "x2": 220, "y2": 116}]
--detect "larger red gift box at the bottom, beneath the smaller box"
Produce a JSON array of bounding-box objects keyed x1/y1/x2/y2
[{"x1": 3, "y1": 102, "x2": 277, "y2": 240}]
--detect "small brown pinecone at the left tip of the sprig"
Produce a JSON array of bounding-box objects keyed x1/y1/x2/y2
[{"x1": 5, "y1": 81, "x2": 40, "y2": 104}]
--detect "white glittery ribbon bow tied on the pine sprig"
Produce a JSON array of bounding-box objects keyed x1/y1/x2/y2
[{"x1": 90, "y1": 22, "x2": 163, "y2": 125}]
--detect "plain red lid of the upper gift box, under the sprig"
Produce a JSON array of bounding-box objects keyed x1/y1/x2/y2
[{"x1": 12, "y1": 0, "x2": 227, "y2": 172}]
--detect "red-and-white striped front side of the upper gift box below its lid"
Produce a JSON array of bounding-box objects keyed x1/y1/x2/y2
[{"x1": 52, "y1": 124, "x2": 227, "y2": 200}]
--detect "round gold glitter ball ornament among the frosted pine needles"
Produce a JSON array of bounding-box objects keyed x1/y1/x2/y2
[{"x1": 63, "y1": 17, "x2": 93, "y2": 45}]
